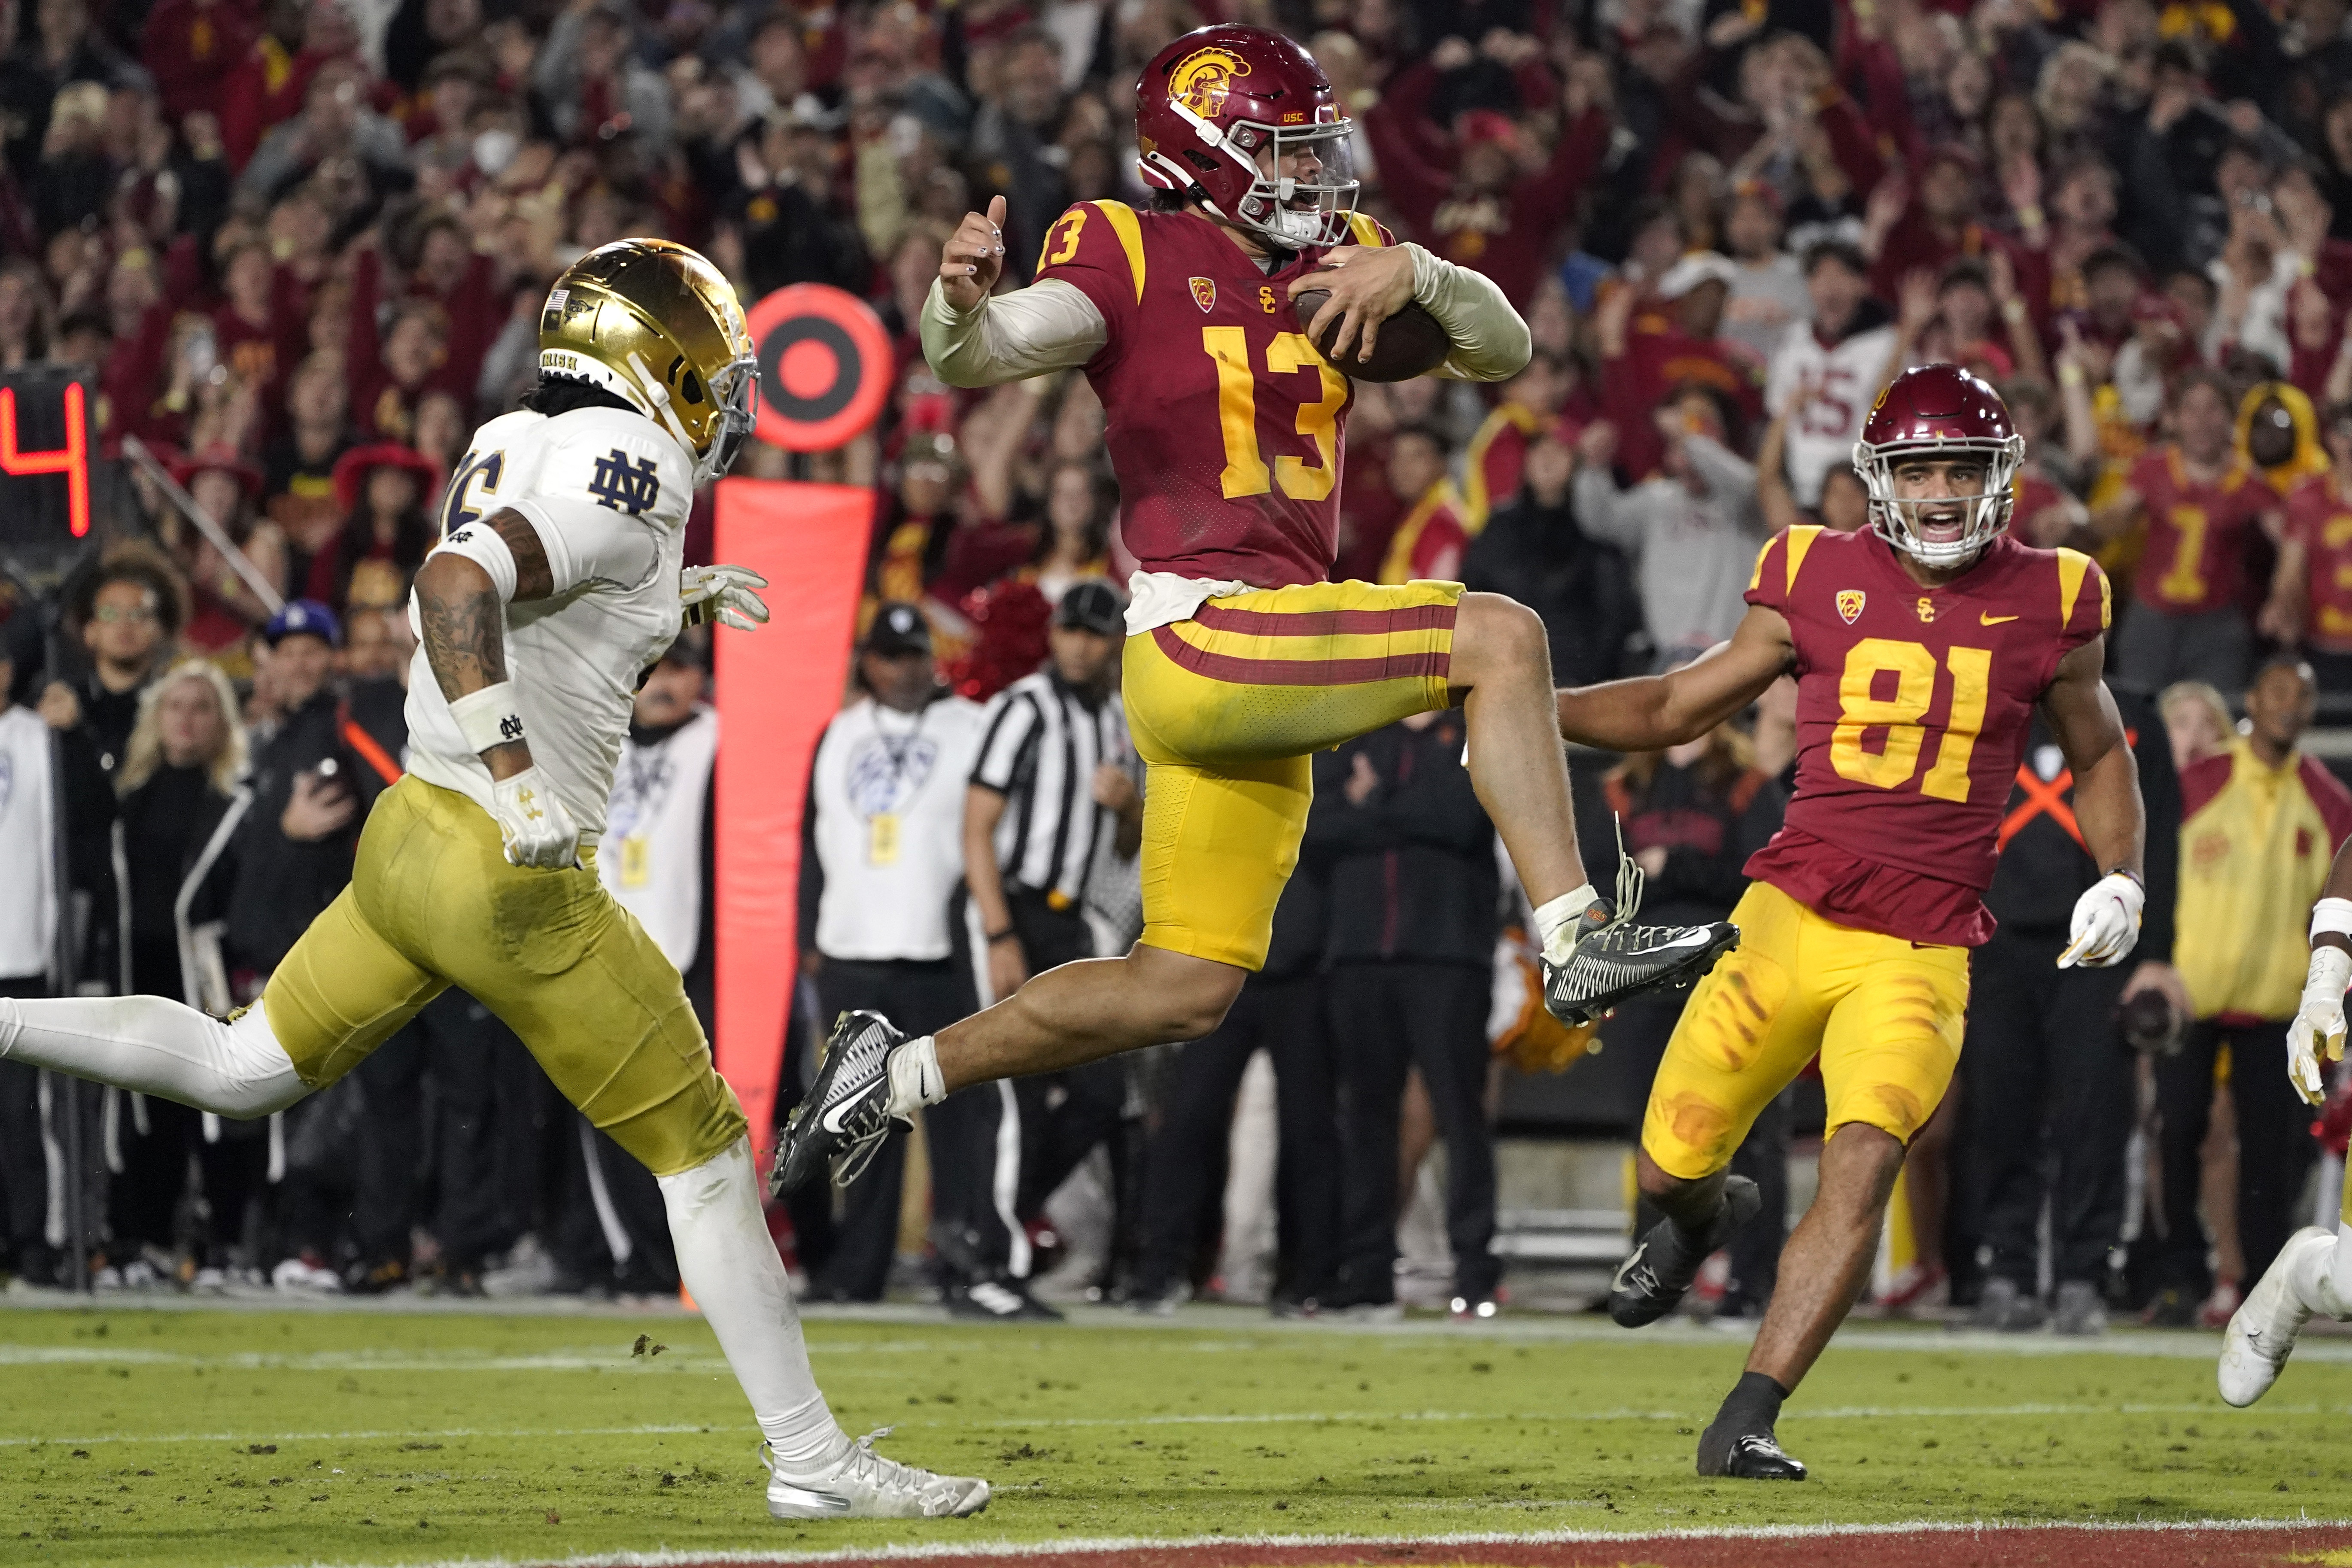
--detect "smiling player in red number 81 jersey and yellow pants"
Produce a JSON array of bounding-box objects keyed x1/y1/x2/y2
[{"x1": 1557, "y1": 365, "x2": 2145, "y2": 1481}]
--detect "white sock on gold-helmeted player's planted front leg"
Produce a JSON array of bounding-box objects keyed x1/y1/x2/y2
[{"x1": 656, "y1": 1138, "x2": 849, "y2": 1474}]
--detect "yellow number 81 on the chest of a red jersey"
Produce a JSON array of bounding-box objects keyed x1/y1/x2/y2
[{"x1": 1830, "y1": 637, "x2": 1992, "y2": 802}]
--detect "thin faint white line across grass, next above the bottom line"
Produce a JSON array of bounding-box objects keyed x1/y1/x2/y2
[{"x1": 14, "y1": 1404, "x2": 2352, "y2": 1457}]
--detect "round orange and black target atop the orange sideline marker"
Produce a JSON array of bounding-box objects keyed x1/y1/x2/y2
[{"x1": 748, "y1": 282, "x2": 891, "y2": 451}]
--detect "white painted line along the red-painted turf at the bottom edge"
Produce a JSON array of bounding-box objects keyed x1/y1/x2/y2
[{"x1": 252, "y1": 1514, "x2": 2352, "y2": 1568}]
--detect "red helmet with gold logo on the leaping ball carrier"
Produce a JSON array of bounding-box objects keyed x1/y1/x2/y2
[{"x1": 1136, "y1": 24, "x2": 1357, "y2": 249}]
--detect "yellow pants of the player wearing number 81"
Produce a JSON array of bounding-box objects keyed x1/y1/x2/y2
[{"x1": 1642, "y1": 881, "x2": 1969, "y2": 1180}]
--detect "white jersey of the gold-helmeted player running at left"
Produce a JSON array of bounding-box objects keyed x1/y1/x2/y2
[{"x1": 409, "y1": 409, "x2": 694, "y2": 846}]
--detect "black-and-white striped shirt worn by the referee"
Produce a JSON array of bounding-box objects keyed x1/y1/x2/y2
[{"x1": 971, "y1": 670, "x2": 1133, "y2": 905}]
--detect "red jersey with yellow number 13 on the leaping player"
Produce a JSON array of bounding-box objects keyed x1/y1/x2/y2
[{"x1": 1037, "y1": 202, "x2": 1390, "y2": 588}]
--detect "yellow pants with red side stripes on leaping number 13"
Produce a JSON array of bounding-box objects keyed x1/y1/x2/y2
[{"x1": 1122, "y1": 583, "x2": 1463, "y2": 969}]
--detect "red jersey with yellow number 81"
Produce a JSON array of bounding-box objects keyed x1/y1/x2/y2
[{"x1": 1747, "y1": 526, "x2": 2110, "y2": 948}]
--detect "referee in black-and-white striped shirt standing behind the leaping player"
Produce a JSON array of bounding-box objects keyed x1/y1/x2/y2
[{"x1": 927, "y1": 580, "x2": 1143, "y2": 1316}]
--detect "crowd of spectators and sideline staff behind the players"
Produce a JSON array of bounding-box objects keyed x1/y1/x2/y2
[{"x1": 0, "y1": 0, "x2": 2352, "y2": 1331}]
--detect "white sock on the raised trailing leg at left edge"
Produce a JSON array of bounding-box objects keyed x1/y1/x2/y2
[{"x1": 0, "y1": 997, "x2": 310, "y2": 1121}]
